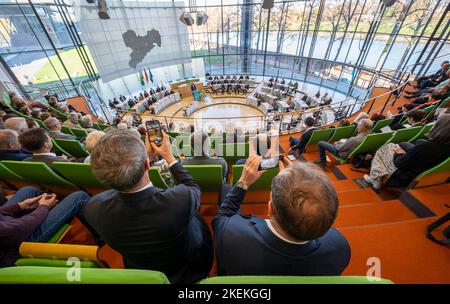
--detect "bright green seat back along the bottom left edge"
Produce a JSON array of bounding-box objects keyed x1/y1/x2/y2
[{"x1": 0, "y1": 266, "x2": 169, "y2": 284}]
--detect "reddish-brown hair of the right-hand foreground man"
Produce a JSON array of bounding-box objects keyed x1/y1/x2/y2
[{"x1": 272, "y1": 162, "x2": 339, "y2": 241}]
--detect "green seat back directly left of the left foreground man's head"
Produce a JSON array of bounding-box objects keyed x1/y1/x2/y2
[{"x1": 53, "y1": 162, "x2": 107, "y2": 189}]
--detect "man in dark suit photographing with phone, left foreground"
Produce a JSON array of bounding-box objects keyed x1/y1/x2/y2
[{"x1": 83, "y1": 129, "x2": 213, "y2": 283}]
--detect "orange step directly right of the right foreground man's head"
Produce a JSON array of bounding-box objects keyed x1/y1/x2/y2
[{"x1": 333, "y1": 200, "x2": 417, "y2": 227}]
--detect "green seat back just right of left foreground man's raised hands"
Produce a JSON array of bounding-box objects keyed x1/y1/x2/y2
[{"x1": 184, "y1": 165, "x2": 223, "y2": 192}]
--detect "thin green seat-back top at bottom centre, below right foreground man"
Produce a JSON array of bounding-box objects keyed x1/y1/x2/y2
[{"x1": 199, "y1": 276, "x2": 394, "y2": 284}]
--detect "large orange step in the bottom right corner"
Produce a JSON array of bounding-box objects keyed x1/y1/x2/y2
[{"x1": 339, "y1": 218, "x2": 450, "y2": 284}]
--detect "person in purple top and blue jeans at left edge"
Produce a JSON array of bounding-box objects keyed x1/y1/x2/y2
[{"x1": 0, "y1": 186, "x2": 89, "y2": 267}]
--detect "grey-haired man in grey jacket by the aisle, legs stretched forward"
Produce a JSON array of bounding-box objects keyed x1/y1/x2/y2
[{"x1": 315, "y1": 119, "x2": 373, "y2": 165}]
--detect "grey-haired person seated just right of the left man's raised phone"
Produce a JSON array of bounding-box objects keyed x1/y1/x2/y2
[{"x1": 182, "y1": 131, "x2": 228, "y2": 180}]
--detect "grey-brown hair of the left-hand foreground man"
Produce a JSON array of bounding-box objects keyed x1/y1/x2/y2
[{"x1": 91, "y1": 129, "x2": 147, "y2": 191}]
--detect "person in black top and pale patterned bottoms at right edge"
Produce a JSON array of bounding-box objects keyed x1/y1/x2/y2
[{"x1": 364, "y1": 114, "x2": 450, "y2": 190}]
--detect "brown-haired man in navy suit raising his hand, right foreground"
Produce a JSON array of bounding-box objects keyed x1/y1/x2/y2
[{"x1": 212, "y1": 156, "x2": 350, "y2": 276}]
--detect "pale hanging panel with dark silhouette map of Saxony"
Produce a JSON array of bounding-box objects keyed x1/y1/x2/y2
[{"x1": 79, "y1": 0, "x2": 191, "y2": 82}]
